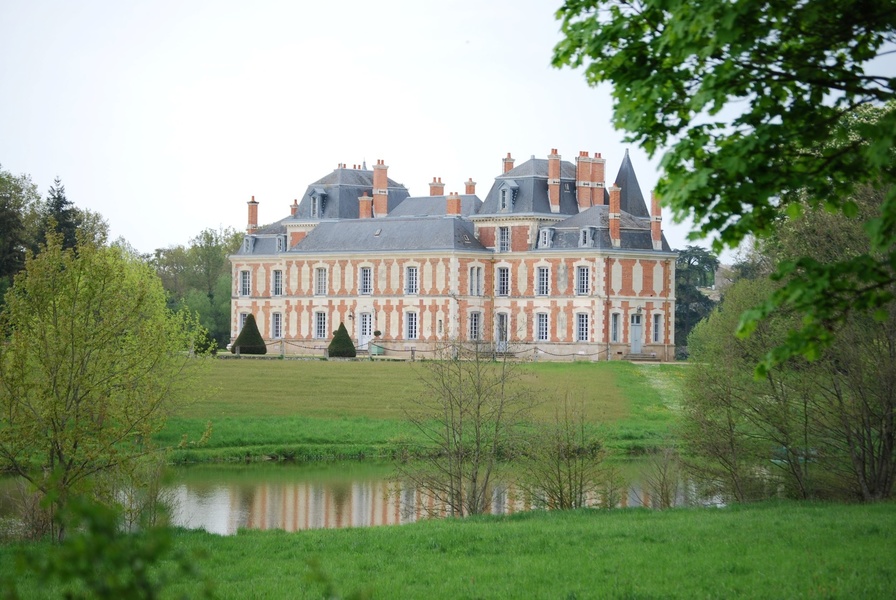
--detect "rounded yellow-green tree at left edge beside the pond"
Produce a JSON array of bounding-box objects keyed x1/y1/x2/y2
[{"x1": 0, "y1": 233, "x2": 205, "y2": 537}]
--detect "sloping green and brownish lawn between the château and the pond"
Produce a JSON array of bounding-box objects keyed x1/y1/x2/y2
[{"x1": 156, "y1": 360, "x2": 686, "y2": 462}]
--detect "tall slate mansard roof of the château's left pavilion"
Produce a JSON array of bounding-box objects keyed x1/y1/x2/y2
[{"x1": 292, "y1": 167, "x2": 410, "y2": 221}]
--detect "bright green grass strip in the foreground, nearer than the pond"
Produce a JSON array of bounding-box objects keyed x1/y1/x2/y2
[{"x1": 0, "y1": 503, "x2": 896, "y2": 600}]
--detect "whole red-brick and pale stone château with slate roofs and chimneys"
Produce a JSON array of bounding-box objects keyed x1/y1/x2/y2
[{"x1": 230, "y1": 150, "x2": 676, "y2": 361}]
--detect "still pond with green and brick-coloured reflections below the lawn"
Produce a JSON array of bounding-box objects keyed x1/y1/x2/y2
[{"x1": 0, "y1": 462, "x2": 700, "y2": 535}]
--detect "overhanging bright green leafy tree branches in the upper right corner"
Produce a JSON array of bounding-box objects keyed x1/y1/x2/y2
[{"x1": 553, "y1": 0, "x2": 896, "y2": 365}]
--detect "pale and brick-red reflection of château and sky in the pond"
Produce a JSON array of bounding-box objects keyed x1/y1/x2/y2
[{"x1": 169, "y1": 480, "x2": 672, "y2": 535}]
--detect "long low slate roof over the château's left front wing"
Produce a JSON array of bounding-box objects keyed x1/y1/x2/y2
[{"x1": 290, "y1": 217, "x2": 491, "y2": 253}]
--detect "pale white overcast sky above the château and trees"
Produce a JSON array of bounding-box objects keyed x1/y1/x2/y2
[{"x1": 0, "y1": 0, "x2": 712, "y2": 252}]
